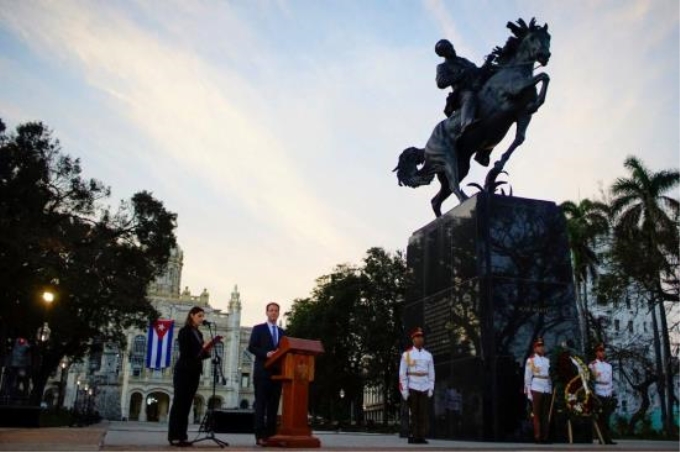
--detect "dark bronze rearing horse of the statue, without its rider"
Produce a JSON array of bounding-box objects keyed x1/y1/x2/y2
[{"x1": 394, "y1": 19, "x2": 550, "y2": 217}]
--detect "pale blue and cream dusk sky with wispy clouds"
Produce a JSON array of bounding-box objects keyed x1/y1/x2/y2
[{"x1": 0, "y1": 0, "x2": 680, "y2": 325}]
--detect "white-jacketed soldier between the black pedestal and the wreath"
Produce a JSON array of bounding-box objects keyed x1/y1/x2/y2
[{"x1": 524, "y1": 337, "x2": 552, "y2": 443}]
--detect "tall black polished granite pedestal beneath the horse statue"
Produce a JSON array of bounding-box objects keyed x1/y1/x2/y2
[{"x1": 404, "y1": 193, "x2": 580, "y2": 441}]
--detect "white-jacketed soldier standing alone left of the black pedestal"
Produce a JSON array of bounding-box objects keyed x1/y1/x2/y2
[{"x1": 399, "y1": 328, "x2": 434, "y2": 444}]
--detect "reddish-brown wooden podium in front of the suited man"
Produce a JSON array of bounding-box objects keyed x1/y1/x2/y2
[{"x1": 264, "y1": 336, "x2": 323, "y2": 447}]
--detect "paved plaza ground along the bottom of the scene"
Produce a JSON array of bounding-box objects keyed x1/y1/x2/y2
[{"x1": 0, "y1": 422, "x2": 678, "y2": 452}]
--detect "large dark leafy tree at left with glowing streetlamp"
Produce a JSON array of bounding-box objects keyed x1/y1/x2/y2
[{"x1": 0, "y1": 123, "x2": 177, "y2": 400}]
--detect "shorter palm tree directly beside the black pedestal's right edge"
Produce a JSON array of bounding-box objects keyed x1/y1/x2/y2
[{"x1": 560, "y1": 199, "x2": 609, "y2": 354}]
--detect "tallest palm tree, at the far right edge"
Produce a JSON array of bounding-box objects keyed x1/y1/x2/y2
[{"x1": 611, "y1": 157, "x2": 680, "y2": 435}]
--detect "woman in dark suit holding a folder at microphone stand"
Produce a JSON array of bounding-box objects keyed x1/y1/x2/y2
[{"x1": 168, "y1": 306, "x2": 220, "y2": 447}]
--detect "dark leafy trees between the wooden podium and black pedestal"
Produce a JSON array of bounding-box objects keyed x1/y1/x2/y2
[{"x1": 287, "y1": 248, "x2": 407, "y2": 422}]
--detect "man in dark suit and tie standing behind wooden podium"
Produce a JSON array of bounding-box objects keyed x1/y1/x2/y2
[{"x1": 248, "y1": 302, "x2": 285, "y2": 446}]
